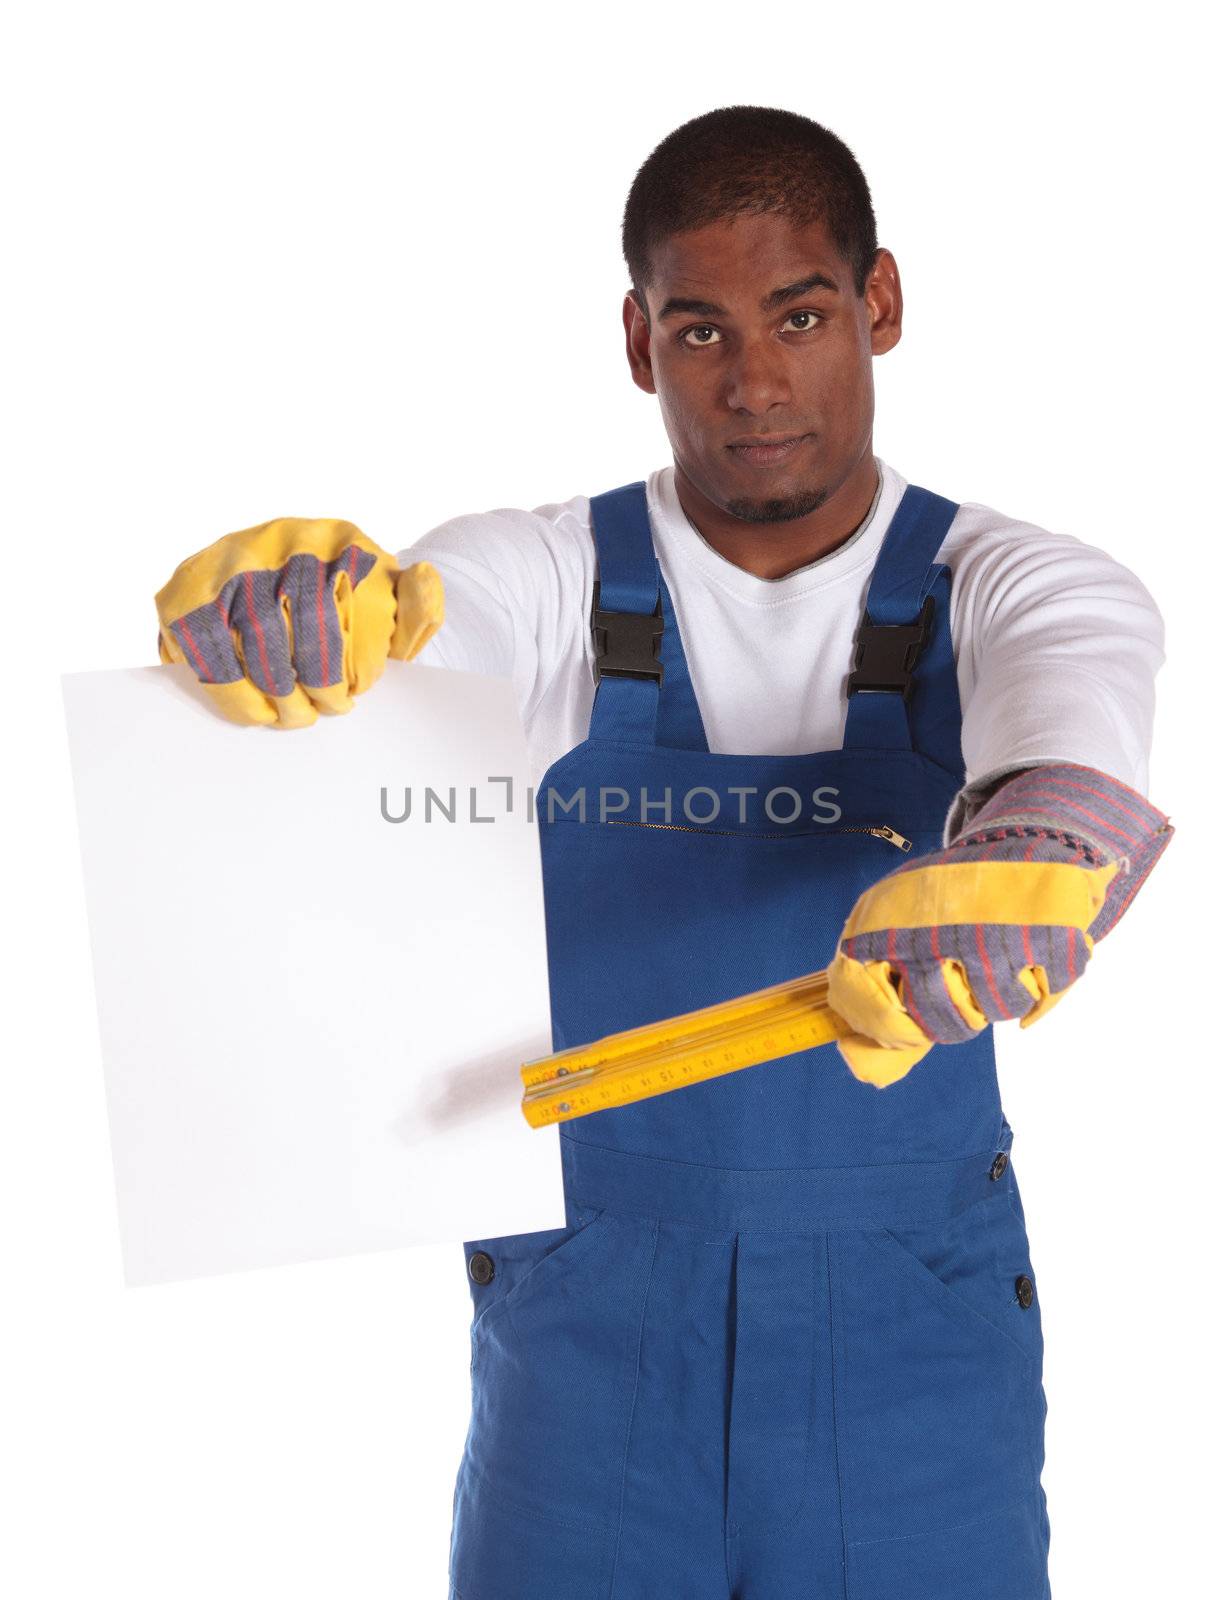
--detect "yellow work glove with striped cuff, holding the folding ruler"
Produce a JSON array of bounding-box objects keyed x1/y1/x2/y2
[{"x1": 829, "y1": 763, "x2": 1175, "y2": 1088}]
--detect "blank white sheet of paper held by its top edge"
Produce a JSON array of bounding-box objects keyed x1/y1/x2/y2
[{"x1": 62, "y1": 662, "x2": 565, "y2": 1285}]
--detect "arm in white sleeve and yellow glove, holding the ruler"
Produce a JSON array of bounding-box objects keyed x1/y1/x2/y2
[{"x1": 831, "y1": 512, "x2": 1173, "y2": 1086}]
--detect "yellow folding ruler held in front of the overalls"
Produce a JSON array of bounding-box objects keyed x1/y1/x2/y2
[{"x1": 522, "y1": 971, "x2": 847, "y2": 1128}]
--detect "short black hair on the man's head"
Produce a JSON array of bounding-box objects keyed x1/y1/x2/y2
[{"x1": 623, "y1": 106, "x2": 877, "y2": 320}]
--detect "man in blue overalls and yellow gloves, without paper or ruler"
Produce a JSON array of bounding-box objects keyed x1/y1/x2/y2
[{"x1": 157, "y1": 107, "x2": 1171, "y2": 1600}]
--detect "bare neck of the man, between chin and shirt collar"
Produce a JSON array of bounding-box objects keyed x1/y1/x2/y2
[{"x1": 674, "y1": 448, "x2": 880, "y2": 578}]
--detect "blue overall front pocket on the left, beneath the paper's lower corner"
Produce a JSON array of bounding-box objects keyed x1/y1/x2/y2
[{"x1": 464, "y1": 1211, "x2": 653, "y2": 1529}]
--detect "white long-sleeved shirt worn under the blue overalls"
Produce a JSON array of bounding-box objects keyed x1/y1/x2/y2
[{"x1": 398, "y1": 461, "x2": 1165, "y2": 840}]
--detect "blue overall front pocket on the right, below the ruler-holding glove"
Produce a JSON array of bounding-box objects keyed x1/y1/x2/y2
[{"x1": 831, "y1": 1205, "x2": 1043, "y2": 1555}]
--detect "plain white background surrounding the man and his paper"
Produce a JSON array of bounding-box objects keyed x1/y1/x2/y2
[{"x1": 0, "y1": 0, "x2": 1213, "y2": 1600}]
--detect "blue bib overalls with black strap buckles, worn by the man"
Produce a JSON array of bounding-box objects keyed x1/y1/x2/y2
[{"x1": 450, "y1": 483, "x2": 1050, "y2": 1600}]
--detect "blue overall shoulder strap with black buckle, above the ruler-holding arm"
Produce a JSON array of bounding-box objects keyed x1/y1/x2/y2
[{"x1": 843, "y1": 483, "x2": 965, "y2": 764}]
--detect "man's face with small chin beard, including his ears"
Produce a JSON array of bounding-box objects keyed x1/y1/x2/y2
[{"x1": 624, "y1": 213, "x2": 901, "y2": 522}]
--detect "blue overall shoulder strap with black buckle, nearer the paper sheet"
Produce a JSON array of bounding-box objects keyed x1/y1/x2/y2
[{"x1": 589, "y1": 480, "x2": 707, "y2": 750}]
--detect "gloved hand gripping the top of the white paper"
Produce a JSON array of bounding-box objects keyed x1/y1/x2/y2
[{"x1": 155, "y1": 517, "x2": 443, "y2": 728}]
